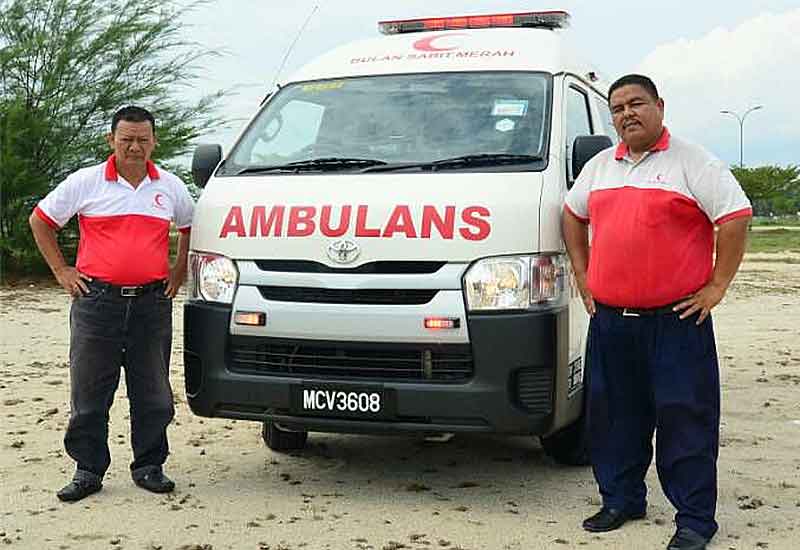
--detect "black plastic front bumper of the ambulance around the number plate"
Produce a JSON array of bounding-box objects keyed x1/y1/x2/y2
[{"x1": 184, "y1": 302, "x2": 569, "y2": 435}]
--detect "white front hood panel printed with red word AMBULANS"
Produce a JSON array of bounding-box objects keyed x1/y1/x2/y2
[{"x1": 191, "y1": 172, "x2": 543, "y2": 267}]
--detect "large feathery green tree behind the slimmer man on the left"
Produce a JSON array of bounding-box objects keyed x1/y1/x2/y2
[{"x1": 0, "y1": 0, "x2": 224, "y2": 275}]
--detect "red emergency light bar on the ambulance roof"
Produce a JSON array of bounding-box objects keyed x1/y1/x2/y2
[{"x1": 378, "y1": 11, "x2": 569, "y2": 34}]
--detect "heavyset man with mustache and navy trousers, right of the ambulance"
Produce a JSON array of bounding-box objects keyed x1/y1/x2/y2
[{"x1": 563, "y1": 75, "x2": 752, "y2": 550}]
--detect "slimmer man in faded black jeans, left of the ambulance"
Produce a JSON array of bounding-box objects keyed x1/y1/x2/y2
[{"x1": 30, "y1": 107, "x2": 194, "y2": 501}]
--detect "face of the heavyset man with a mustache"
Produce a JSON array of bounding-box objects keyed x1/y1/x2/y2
[{"x1": 609, "y1": 84, "x2": 664, "y2": 153}]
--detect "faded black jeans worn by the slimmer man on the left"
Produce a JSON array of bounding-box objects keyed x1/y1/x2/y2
[{"x1": 64, "y1": 283, "x2": 175, "y2": 478}]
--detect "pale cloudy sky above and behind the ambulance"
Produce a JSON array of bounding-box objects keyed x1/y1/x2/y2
[{"x1": 184, "y1": 0, "x2": 800, "y2": 166}]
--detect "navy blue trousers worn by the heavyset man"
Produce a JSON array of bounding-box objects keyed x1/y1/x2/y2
[{"x1": 589, "y1": 306, "x2": 720, "y2": 539}]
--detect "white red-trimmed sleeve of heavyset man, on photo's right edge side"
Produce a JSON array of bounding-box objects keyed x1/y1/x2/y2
[{"x1": 688, "y1": 159, "x2": 753, "y2": 224}]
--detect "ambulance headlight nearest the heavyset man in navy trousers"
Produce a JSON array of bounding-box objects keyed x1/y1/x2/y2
[{"x1": 464, "y1": 254, "x2": 567, "y2": 311}]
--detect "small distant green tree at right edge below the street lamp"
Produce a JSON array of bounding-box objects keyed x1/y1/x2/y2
[{"x1": 732, "y1": 165, "x2": 800, "y2": 216}]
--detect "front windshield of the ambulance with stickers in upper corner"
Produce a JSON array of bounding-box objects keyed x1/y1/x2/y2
[{"x1": 223, "y1": 72, "x2": 552, "y2": 175}]
